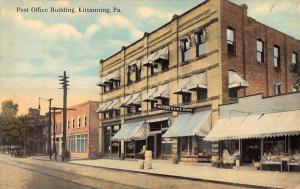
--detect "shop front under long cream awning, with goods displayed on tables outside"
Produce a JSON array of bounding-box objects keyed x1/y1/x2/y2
[{"x1": 205, "y1": 110, "x2": 300, "y2": 170}]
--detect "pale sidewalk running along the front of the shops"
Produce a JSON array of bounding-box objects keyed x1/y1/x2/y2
[{"x1": 28, "y1": 156, "x2": 300, "y2": 189}]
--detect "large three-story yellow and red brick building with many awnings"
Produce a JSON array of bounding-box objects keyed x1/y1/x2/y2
[{"x1": 97, "y1": 0, "x2": 300, "y2": 161}]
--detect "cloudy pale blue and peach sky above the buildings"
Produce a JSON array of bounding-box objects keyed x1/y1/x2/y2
[{"x1": 0, "y1": 0, "x2": 300, "y2": 114}]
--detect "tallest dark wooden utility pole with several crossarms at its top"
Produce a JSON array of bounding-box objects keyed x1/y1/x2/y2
[{"x1": 59, "y1": 71, "x2": 69, "y2": 161}]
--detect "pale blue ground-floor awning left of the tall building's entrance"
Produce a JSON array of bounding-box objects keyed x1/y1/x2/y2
[{"x1": 111, "y1": 121, "x2": 149, "y2": 141}]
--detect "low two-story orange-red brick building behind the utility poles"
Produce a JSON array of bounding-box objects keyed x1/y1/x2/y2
[{"x1": 51, "y1": 101, "x2": 99, "y2": 158}]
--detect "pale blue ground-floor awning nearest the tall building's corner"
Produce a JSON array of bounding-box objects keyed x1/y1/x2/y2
[{"x1": 163, "y1": 110, "x2": 211, "y2": 138}]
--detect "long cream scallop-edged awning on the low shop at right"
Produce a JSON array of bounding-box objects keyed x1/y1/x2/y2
[{"x1": 204, "y1": 110, "x2": 300, "y2": 141}]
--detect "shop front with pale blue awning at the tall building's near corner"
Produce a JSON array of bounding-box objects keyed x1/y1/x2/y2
[{"x1": 163, "y1": 110, "x2": 211, "y2": 162}]
